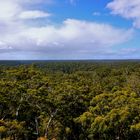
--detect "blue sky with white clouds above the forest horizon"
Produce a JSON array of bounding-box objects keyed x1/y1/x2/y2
[{"x1": 0, "y1": 0, "x2": 140, "y2": 60}]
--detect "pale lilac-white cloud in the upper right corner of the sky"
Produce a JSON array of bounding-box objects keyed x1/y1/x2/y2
[{"x1": 107, "y1": 0, "x2": 140, "y2": 28}]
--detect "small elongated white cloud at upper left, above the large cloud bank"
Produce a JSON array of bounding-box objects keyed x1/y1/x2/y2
[{"x1": 19, "y1": 10, "x2": 50, "y2": 19}]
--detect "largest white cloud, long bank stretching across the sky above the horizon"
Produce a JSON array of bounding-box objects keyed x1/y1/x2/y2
[{"x1": 0, "y1": 19, "x2": 133, "y2": 59}]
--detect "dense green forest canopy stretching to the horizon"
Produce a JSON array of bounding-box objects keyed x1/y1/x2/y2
[{"x1": 0, "y1": 60, "x2": 140, "y2": 140}]
